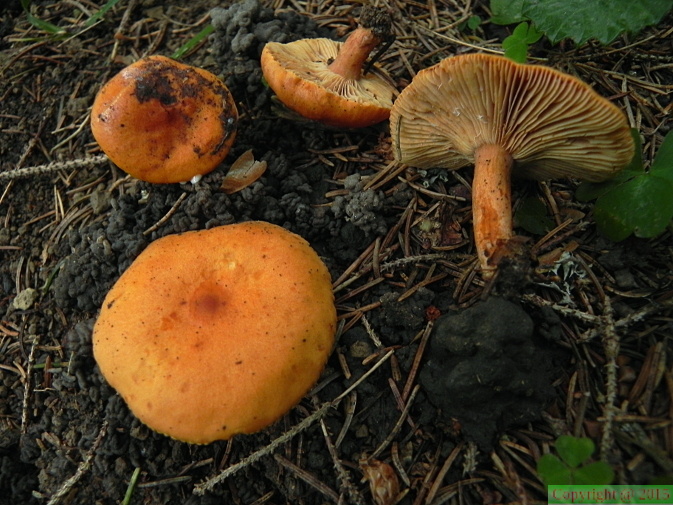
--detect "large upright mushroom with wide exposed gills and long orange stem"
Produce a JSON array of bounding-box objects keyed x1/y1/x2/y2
[{"x1": 390, "y1": 54, "x2": 634, "y2": 278}]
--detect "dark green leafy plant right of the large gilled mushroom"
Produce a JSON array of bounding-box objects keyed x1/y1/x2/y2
[{"x1": 575, "y1": 130, "x2": 673, "y2": 242}]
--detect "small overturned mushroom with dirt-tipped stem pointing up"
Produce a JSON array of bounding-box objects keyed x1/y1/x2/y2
[{"x1": 261, "y1": 6, "x2": 397, "y2": 128}]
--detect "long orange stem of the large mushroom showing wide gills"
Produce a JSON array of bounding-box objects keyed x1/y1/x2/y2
[{"x1": 472, "y1": 144, "x2": 514, "y2": 279}]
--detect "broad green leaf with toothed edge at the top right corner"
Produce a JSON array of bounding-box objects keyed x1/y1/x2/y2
[{"x1": 516, "y1": 0, "x2": 673, "y2": 44}]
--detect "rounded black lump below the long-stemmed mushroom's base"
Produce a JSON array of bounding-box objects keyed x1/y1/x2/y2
[{"x1": 420, "y1": 297, "x2": 553, "y2": 451}]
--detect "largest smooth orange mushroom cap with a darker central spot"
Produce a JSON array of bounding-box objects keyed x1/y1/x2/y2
[{"x1": 93, "y1": 221, "x2": 336, "y2": 444}]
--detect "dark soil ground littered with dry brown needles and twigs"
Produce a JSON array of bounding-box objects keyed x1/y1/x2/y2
[{"x1": 0, "y1": 0, "x2": 673, "y2": 505}]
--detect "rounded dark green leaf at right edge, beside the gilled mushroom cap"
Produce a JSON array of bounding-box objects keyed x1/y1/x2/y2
[{"x1": 594, "y1": 171, "x2": 673, "y2": 242}]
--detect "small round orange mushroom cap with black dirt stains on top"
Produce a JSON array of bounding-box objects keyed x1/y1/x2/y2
[{"x1": 91, "y1": 56, "x2": 238, "y2": 183}]
